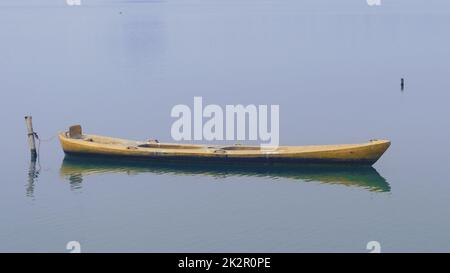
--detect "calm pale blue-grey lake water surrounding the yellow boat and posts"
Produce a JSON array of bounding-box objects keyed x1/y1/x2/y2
[{"x1": 0, "y1": 0, "x2": 450, "y2": 252}]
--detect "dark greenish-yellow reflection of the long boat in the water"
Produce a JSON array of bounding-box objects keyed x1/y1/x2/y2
[{"x1": 60, "y1": 155, "x2": 391, "y2": 192}]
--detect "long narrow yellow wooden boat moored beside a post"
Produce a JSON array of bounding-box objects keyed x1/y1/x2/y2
[{"x1": 59, "y1": 125, "x2": 390, "y2": 166}]
